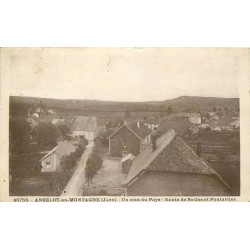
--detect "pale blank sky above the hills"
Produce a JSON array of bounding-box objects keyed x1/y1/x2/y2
[{"x1": 7, "y1": 48, "x2": 243, "y2": 101}]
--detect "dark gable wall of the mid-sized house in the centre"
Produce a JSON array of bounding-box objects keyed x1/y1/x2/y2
[{"x1": 109, "y1": 126, "x2": 141, "y2": 157}]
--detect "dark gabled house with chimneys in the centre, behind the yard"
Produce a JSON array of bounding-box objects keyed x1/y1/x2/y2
[{"x1": 108, "y1": 121, "x2": 151, "y2": 158}]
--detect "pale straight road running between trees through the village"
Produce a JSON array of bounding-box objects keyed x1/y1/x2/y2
[{"x1": 61, "y1": 141, "x2": 94, "y2": 196}]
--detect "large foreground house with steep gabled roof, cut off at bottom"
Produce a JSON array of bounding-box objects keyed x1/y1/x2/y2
[{"x1": 125, "y1": 130, "x2": 231, "y2": 196}]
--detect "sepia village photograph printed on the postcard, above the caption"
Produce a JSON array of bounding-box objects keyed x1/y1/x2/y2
[{"x1": 0, "y1": 48, "x2": 247, "y2": 197}]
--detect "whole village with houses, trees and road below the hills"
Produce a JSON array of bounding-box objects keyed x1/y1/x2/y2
[{"x1": 9, "y1": 96, "x2": 240, "y2": 196}]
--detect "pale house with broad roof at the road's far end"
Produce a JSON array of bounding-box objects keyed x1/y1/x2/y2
[{"x1": 70, "y1": 116, "x2": 97, "y2": 141}]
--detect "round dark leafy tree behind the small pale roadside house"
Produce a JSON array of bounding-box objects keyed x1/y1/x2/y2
[{"x1": 33, "y1": 122, "x2": 59, "y2": 149}]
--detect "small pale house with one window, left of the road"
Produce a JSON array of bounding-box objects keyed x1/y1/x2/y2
[{"x1": 40, "y1": 141, "x2": 77, "y2": 173}]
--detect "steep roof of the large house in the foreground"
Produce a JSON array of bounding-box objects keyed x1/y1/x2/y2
[{"x1": 126, "y1": 129, "x2": 228, "y2": 186}]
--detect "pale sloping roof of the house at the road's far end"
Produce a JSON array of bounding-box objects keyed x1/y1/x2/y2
[{"x1": 70, "y1": 116, "x2": 96, "y2": 132}]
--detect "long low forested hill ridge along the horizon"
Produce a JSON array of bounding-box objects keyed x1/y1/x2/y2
[{"x1": 10, "y1": 96, "x2": 239, "y2": 115}]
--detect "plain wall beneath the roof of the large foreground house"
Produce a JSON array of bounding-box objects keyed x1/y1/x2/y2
[{"x1": 127, "y1": 171, "x2": 231, "y2": 196}]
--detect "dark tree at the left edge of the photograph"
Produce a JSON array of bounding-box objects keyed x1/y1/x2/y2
[{"x1": 9, "y1": 118, "x2": 31, "y2": 153}]
